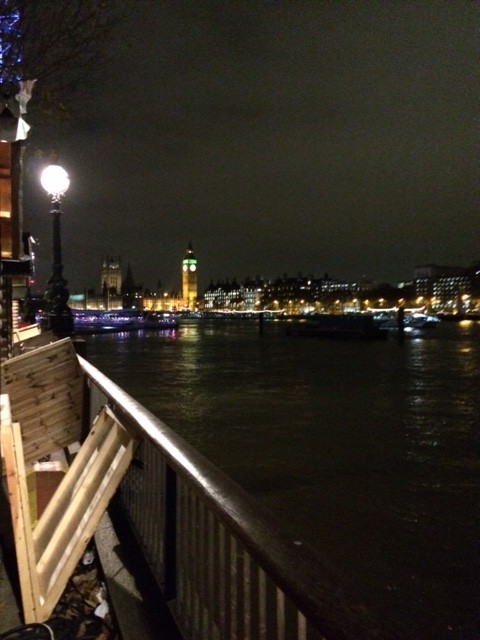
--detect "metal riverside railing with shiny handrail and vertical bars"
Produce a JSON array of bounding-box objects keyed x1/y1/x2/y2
[{"x1": 79, "y1": 356, "x2": 401, "y2": 640}]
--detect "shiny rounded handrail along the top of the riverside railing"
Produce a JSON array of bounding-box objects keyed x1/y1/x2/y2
[{"x1": 78, "y1": 356, "x2": 403, "y2": 640}]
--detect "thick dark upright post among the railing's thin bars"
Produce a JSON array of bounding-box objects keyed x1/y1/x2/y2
[{"x1": 164, "y1": 464, "x2": 177, "y2": 600}]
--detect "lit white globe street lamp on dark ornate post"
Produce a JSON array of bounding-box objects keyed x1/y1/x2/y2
[{"x1": 40, "y1": 164, "x2": 73, "y2": 338}]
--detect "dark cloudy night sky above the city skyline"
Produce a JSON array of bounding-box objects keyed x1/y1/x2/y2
[{"x1": 25, "y1": 0, "x2": 480, "y2": 290}]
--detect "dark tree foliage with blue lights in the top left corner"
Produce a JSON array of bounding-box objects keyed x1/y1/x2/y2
[{"x1": 0, "y1": 0, "x2": 128, "y2": 120}]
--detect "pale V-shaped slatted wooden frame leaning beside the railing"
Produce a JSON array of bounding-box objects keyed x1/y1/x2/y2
[{"x1": 1, "y1": 407, "x2": 141, "y2": 623}]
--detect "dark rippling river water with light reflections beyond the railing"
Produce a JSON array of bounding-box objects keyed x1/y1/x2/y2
[{"x1": 80, "y1": 320, "x2": 480, "y2": 640}]
